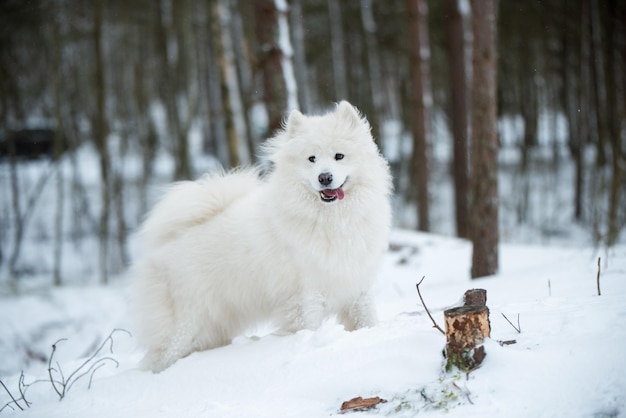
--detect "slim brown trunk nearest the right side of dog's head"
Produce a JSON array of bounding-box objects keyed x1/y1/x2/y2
[{"x1": 406, "y1": 0, "x2": 432, "y2": 231}]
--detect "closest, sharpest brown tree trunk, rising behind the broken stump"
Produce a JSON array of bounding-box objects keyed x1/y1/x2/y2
[{"x1": 471, "y1": 0, "x2": 499, "y2": 278}]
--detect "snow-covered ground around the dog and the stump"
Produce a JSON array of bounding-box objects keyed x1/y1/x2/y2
[{"x1": 0, "y1": 230, "x2": 626, "y2": 418}]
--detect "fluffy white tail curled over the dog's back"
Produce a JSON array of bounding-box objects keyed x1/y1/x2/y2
[{"x1": 140, "y1": 169, "x2": 260, "y2": 248}]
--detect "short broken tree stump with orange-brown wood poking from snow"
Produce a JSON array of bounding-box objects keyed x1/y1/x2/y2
[{"x1": 444, "y1": 289, "x2": 491, "y2": 371}]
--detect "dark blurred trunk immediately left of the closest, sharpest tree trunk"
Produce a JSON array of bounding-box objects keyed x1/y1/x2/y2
[{"x1": 444, "y1": 0, "x2": 470, "y2": 238}]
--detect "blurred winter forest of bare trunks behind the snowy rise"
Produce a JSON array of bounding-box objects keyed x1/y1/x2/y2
[{"x1": 0, "y1": 0, "x2": 626, "y2": 291}]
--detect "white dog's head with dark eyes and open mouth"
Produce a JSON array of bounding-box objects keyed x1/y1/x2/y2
[{"x1": 262, "y1": 101, "x2": 378, "y2": 204}]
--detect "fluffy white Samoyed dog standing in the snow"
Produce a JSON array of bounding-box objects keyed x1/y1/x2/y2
[{"x1": 133, "y1": 101, "x2": 392, "y2": 371}]
